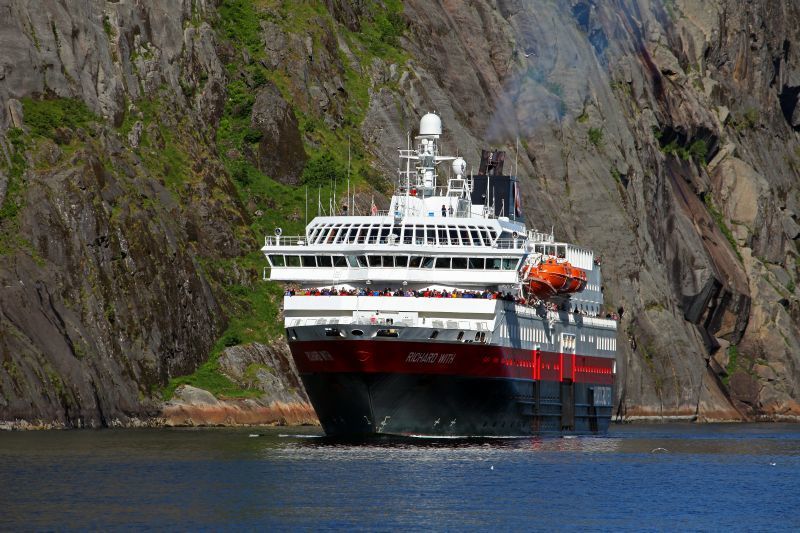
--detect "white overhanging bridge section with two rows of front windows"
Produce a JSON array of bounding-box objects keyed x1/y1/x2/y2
[{"x1": 262, "y1": 216, "x2": 527, "y2": 288}]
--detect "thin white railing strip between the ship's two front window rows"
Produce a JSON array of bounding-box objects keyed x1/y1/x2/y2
[{"x1": 264, "y1": 234, "x2": 525, "y2": 250}]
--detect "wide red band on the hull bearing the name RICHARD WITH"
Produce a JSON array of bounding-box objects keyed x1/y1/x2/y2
[{"x1": 289, "y1": 339, "x2": 614, "y2": 385}]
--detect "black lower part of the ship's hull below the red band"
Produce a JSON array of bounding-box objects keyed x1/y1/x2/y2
[{"x1": 302, "y1": 373, "x2": 611, "y2": 437}]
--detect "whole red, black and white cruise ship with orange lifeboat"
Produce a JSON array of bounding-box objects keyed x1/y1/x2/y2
[{"x1": 262, "y1": 113, "x2": 617, "y2": 437}]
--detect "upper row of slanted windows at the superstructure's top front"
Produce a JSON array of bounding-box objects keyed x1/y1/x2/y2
[{"x1": 308, "y1": 224, "x2": 497, "y2": 246}]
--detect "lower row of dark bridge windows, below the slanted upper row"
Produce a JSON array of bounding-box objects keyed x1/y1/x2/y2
[{"x1": 268, "y1": 255, "x2": 520, "y2": 270}]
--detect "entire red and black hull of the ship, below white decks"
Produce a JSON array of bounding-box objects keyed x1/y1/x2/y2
[{"x1": 290, "y1": 340, "x2": 613, "y2": 438}]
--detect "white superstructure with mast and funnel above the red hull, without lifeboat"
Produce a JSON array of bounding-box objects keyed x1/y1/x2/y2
[{"x1": 262, "y1": 113, "x2": 616, "y2": 349}]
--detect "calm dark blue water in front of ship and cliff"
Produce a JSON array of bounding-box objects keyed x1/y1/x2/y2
[{"x1": 0, "y1": 424, "x2": 800, "y2": 531}]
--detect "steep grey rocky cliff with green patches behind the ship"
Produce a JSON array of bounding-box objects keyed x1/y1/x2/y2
[{"x1": 0, "y1": 0, "x2": 800, "y2": 426}]
